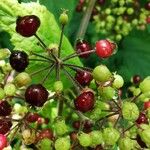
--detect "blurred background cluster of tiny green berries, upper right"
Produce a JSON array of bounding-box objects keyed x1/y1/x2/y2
[{"x1": 76, "y1": 0, "x2": 150, "y2": 42}]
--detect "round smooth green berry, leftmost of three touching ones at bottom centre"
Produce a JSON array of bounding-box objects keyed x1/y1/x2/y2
[{"x1": 78, "y1": 132, "x2": 92, "y2": 147}]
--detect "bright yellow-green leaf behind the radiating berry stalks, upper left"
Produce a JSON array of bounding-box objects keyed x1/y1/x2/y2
[{"x1": 0, "y1": 0, "x2": 82, "y2": 88}]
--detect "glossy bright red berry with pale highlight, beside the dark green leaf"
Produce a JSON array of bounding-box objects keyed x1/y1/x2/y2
[{"x1": 96, "y1": 40, "x2": 115, "y2": 58}]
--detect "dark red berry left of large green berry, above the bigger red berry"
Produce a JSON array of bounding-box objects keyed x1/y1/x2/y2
[{"x1": 75, "y1": 71, "x2": 93, "y2": 86}]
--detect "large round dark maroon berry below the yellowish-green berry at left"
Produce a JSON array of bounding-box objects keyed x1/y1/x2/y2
[{"x1": 25, "y1": 84, "x2": 48, "y2": 107}]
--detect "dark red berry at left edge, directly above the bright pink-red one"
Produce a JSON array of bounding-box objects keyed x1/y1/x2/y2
[{"x1": 0, "y1": 119, "x2": 12, "y2": 134}]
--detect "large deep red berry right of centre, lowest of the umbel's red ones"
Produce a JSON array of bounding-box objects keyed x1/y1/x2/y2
[{"x1": 74, "y1": 91, "x2": 95, "y2": 112}]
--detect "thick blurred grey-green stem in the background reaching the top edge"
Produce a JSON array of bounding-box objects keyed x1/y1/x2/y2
[{"x1": 76, "y1": 0, "x2": 96, "y2": 39}]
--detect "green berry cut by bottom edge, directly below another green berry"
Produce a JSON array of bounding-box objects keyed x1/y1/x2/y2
[{"x1": 55, "y1": 137, "x2": 71, "y2": 150}]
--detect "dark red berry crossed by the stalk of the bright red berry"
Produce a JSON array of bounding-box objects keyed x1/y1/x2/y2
[{"x1": 76, "y1": 40, "x2": 91, "y2": 58}]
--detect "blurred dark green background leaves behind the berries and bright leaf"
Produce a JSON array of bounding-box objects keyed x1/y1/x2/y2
[{"x1": 0, "y1": 0, "x2": 150, "y2": 82}]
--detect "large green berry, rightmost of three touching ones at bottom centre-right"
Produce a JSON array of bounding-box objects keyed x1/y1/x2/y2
[{"x1": 103, "y1": 127, "x2": 120, "y2": 145}]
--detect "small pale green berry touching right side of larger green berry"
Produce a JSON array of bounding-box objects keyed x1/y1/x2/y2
[{"x1": 112, "y1": 74, "x2": 124, "y2": 89}]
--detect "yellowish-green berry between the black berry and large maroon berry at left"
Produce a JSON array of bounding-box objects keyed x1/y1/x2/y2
[{"x1": 15, "y1": 72, "x2": 31, "y2": 87}]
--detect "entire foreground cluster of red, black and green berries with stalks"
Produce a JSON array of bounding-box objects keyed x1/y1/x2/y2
[{"x1": 0, "y1": 7, "x2": 150, "y2": 150}]
